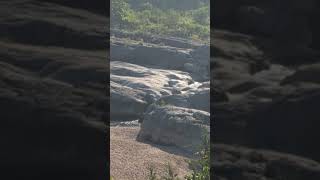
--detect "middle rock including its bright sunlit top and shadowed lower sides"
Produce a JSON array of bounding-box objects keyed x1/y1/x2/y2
[{"x1": 110, "y1": 61, "x2": 209, "y2": 120}]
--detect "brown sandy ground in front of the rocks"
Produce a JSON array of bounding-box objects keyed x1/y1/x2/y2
[{"x1": 110, "y1": 127, "x2": 190, "y2": 180}]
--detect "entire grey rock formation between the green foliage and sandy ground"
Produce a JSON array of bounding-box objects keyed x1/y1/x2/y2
[{"x1": 110, "y1": 32, "x2": 210, "y2": 152}]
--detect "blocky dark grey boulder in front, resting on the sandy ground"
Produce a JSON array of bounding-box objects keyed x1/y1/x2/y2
[{"x1": 137, "y1": 104, "x2": 210, "y2": 152}]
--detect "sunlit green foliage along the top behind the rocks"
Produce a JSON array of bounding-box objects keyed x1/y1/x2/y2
[{"x1": 111, "y1": 0, "x2": 210, "y2": 41}]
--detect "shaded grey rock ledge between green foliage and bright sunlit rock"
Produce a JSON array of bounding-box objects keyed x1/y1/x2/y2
[{"x1": 111, "y1": 37, "x2": 210, "y2": 82}]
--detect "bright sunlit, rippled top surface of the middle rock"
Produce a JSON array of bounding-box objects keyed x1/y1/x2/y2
[{"x1": 110, "y1": 61, "x2": 192, "y2": 99}]
